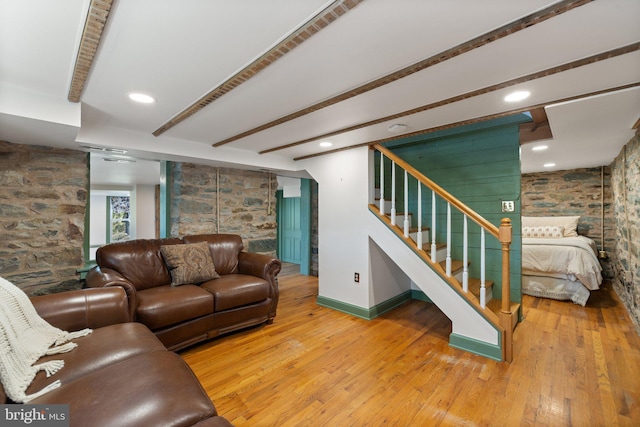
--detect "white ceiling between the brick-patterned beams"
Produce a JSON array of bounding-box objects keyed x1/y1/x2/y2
[{"x1": 0, "y1": 0, "x2": 640, "y2": 184}]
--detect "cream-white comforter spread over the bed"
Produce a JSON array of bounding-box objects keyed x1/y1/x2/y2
[{"x1": 522, "y1": 236, "x2": 602, "y2": 290}]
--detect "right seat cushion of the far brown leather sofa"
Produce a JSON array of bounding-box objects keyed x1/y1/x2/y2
[{"x1": 200, "y1": 274, "x2": 269, "y2": 312}]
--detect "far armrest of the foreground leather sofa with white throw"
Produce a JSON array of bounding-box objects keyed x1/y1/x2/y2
[{"x1": 31, "y1": 287, "x2": 130, "y2": 332}]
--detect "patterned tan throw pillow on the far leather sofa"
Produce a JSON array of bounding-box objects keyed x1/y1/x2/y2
[{"x1": 160, "y1": 242, "x2": 220, "y2": 286}]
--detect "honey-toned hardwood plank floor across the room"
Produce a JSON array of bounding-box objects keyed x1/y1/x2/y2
[{"x1": 181, "y1": 275, "x2": 640, "y2": 426}]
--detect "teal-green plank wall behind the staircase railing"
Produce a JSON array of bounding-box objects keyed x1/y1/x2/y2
[{"x1": 376, "y1": 114, "x2": 530, "y2": 302}]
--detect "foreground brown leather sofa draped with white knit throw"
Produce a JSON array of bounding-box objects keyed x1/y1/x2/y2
[{"x1": 0, "y1": 287, "x2": 231, "y2": 427}]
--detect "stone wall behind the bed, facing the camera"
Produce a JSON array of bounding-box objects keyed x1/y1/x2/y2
[{"x1": 521, "y1": 166, "x2": 616, "y2": 278}]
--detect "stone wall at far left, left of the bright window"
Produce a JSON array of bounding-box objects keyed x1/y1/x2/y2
[{"x1": 0, "y1": 141, "x2": 89, "y2": 295}]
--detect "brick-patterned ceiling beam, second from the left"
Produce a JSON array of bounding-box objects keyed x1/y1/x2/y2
[{"x1": 153, "y1": 0, "x2": 364, "y2": 136}]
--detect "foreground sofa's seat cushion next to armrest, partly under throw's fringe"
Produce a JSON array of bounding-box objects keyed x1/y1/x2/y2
[{"x1": 27, "y1": 323, "x2": 165, "y2": 394}]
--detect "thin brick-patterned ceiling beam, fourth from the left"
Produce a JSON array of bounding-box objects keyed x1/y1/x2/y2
[{"x1": 260, "y1": 42, "x2": 640, "y2": 154}]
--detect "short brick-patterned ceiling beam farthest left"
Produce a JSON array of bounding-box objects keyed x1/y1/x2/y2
[{"x1": 67, "y1": 0, "x2": 113, "y2": 102}]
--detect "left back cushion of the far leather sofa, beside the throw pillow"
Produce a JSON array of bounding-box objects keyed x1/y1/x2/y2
[{"x1": 96, "y1": 238, "x2": 182, "y2": 290}]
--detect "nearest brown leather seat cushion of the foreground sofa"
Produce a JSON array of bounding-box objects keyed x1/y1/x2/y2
[{"x1": 29, "y1": 351, "x2": 217, "y2": 427}]
